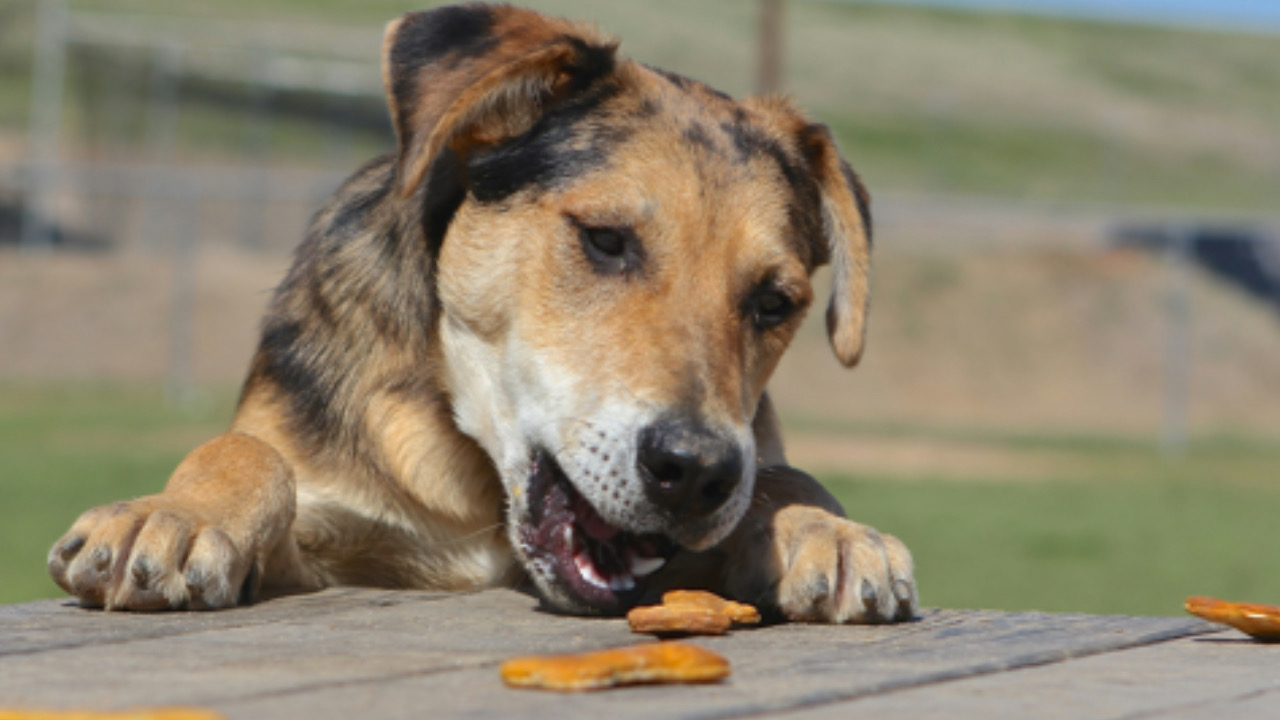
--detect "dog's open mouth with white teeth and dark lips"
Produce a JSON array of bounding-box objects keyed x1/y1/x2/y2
[{"x1": 521, "y1": 452, "x2": 677, "y2": 612}]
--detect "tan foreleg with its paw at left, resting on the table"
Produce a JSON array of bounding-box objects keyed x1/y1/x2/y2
[{"x1": 49, "y1": 432, "x2": 308, "y2": 610}]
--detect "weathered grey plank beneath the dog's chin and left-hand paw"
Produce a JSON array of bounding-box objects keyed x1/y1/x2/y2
[{"x1": 0, "y1": 591, "x2": 631, "y2": 708}]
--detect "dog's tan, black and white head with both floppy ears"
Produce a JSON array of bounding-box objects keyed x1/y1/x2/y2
[{"x1": 384, "y1": 4, "x2": 869, "y2": 611}]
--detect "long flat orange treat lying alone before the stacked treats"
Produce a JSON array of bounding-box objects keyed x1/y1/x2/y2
[{"x1": 499, "y1": 642, "x2": 728, "y2": 692}]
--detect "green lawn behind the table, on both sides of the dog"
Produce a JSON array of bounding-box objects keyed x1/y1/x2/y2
[{"x1": 0, "y1": 384, "x2": 1280, "y2": 615}]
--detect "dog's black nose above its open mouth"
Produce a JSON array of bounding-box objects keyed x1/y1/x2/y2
[{"x1": 637, "y1": 421, "x2": 742, "y2": 515}]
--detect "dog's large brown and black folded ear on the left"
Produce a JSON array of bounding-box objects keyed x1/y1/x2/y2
[{"x1": 383, "y1": 3, "x2": 617, "y2": 197}]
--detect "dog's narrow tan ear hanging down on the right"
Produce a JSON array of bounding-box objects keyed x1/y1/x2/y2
[{"x1": 800, "y1": 123, "x2": 872, "y2": 368}]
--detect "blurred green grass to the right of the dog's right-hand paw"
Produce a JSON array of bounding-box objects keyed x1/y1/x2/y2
[{"x1": 823, "y1": 466, "x2": 1280, "y2": 615}]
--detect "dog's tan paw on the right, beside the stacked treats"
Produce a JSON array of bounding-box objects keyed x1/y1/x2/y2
[{"x1": 773, "y1": 505, "x2": 916, "y2": 623}]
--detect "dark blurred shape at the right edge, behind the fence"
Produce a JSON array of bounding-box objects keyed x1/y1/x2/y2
[{"x1": 1114, "y1": 224, "x2": 1280, "y2": 313}]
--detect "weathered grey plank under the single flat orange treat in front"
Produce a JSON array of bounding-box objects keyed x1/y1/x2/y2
[{"x1": 209, "y1": 604, "x2": 1199, "y2": 717}]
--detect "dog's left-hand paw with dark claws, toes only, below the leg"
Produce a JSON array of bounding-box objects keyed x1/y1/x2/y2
[{"x1": 49, "y1": 496, "x2": 252, "y2": 610}]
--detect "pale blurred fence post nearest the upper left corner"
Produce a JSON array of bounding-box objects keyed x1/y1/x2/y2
[{"x1": 18, "y1": 0, "x2": 67, "y2": 249}]
